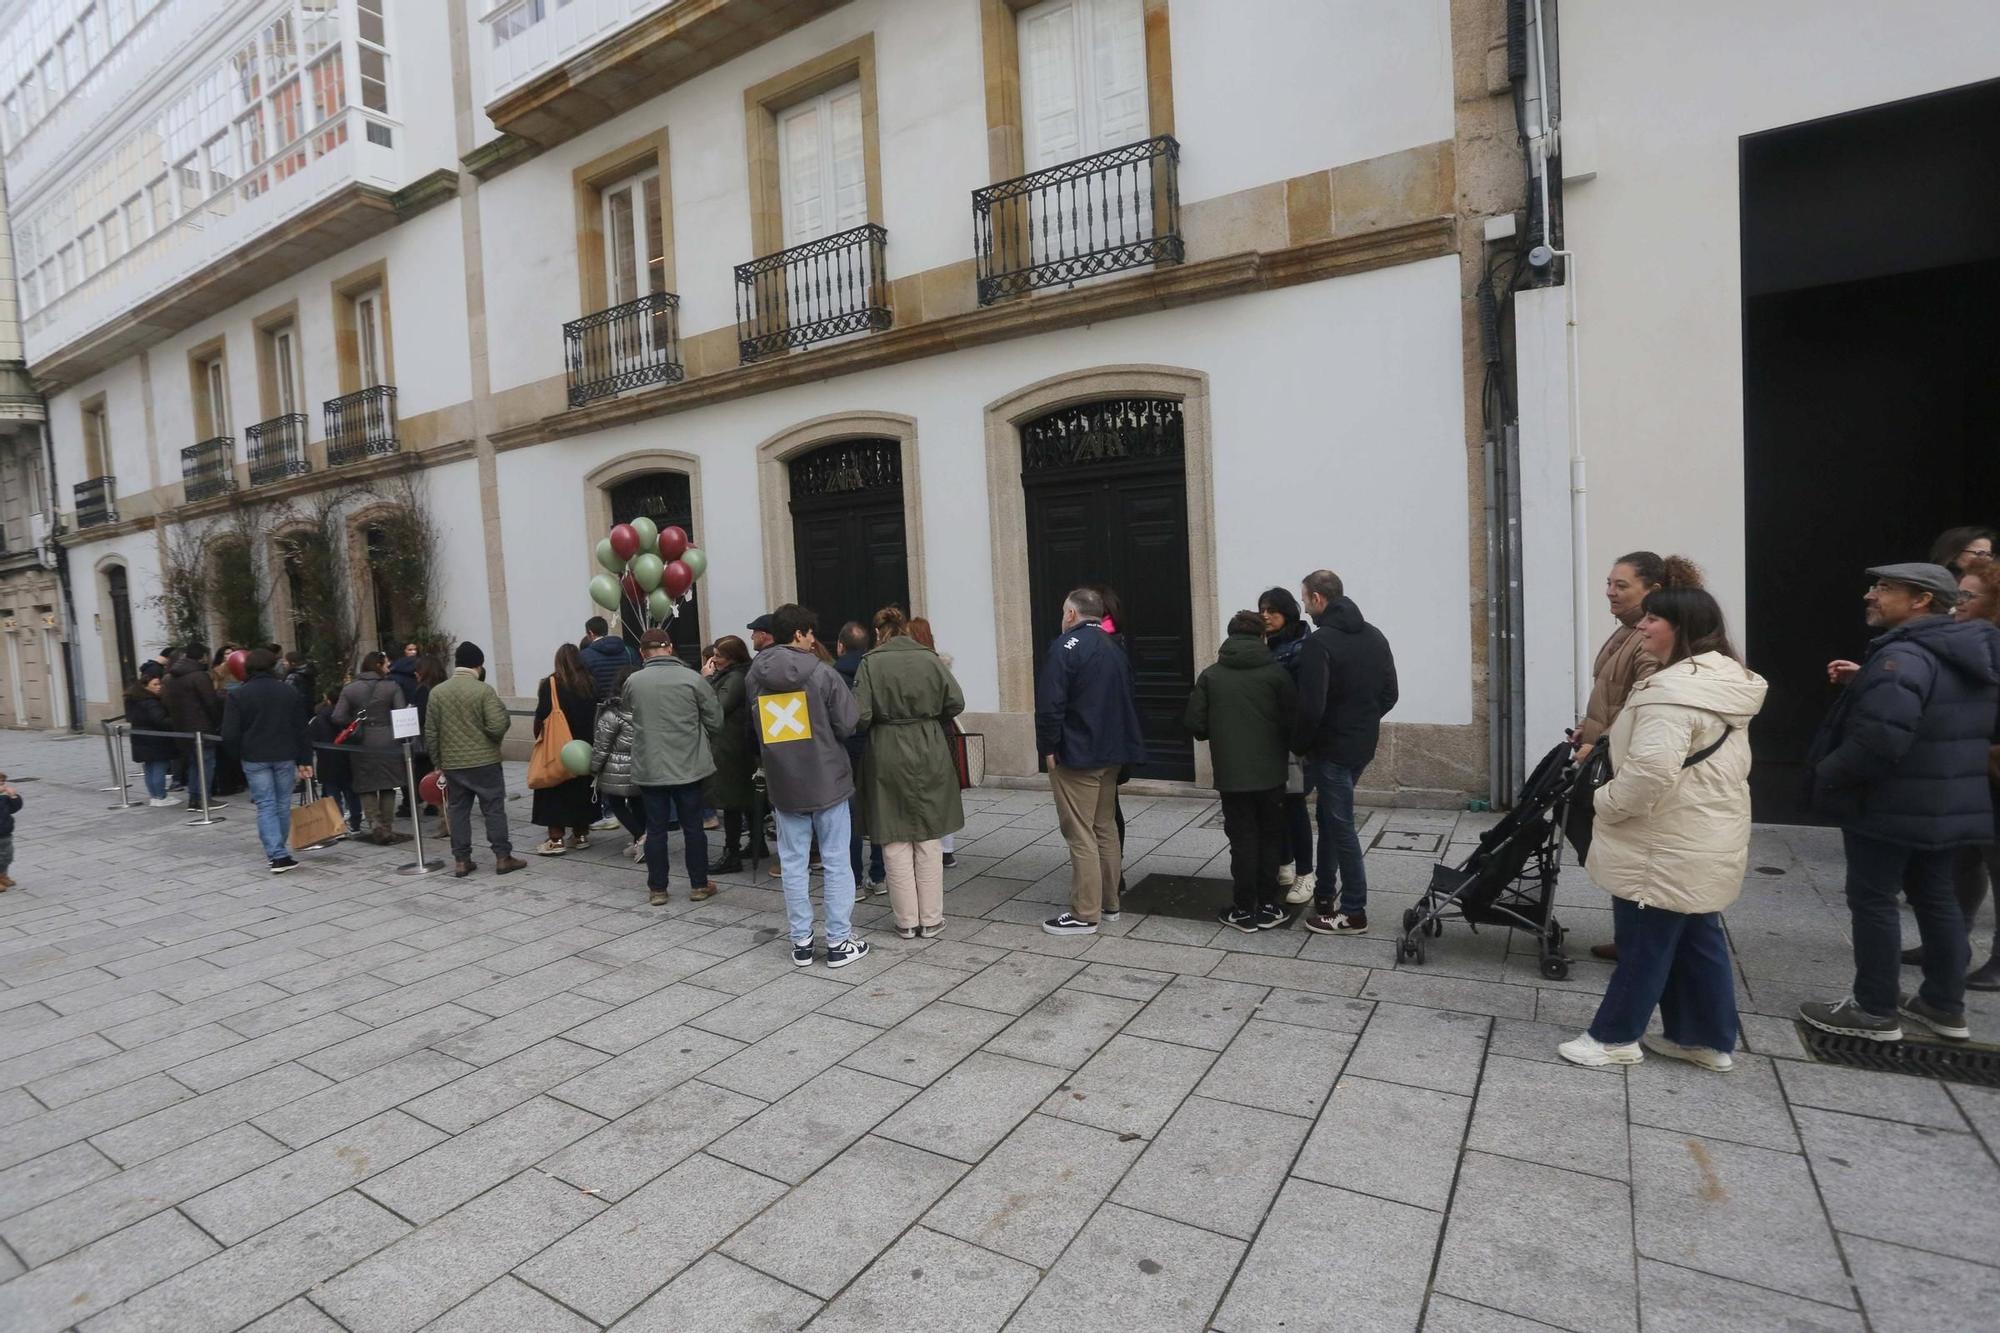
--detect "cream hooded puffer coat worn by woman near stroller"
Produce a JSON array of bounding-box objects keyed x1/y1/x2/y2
[{"x1": 1588, "y1": 652, "x2": 1766, "y2": 913}]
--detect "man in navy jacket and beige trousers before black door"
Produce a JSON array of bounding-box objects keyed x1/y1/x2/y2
[{"x1": 1034, "y1": 588, "x2": 1146, "y2": 935}]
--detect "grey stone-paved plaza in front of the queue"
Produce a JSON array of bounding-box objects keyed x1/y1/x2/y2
[{"x1": 0, "y1": 733, "x2": 2000, "y2": 1333}]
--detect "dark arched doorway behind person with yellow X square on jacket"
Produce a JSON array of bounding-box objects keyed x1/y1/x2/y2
[{"x1": 786, "y1": 438, "x2": 910, "y2": 650}]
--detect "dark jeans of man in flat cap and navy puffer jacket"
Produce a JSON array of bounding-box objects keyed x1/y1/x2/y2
[{"x1": 1840, "y1": 833, "x2": 1972, "y2": 1019}]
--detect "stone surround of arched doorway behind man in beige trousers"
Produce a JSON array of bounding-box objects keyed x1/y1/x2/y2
[{"x1": 982, "y1": 364, "x2": 1222, "y2": 787}]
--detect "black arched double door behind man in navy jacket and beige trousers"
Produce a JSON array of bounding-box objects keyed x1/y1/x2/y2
[{"x1": 1020, "y1": 396, "x2": 1194, "y2": 781}]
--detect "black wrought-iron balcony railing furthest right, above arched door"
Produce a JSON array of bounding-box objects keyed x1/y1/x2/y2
[{"x1": 972, "y1": 134, "x2": 1188, "y2": 306}]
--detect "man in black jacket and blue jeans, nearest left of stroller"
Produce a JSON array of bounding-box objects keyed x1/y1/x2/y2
[{"x1": 1292, "y1": 568, "x2": 1396, "y2": 935}]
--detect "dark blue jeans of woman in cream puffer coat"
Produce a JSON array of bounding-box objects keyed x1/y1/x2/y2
[{"x1": 1590, "y1": 899, "x2": 1736, "y2": 1053}]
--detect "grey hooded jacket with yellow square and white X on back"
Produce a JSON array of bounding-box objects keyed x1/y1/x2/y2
[{"x1": 744, "y1": 644, "x2": 860, "y2": 815}]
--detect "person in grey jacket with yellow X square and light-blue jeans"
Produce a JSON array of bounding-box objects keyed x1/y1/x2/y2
[{"x1": 744, "y1": 602, "x2": 868, "y2": 967}]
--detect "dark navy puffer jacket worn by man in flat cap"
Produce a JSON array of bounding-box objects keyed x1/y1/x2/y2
[{"x1": 1806, "y1": 616, "x2": 2000, "y2": 849}]
